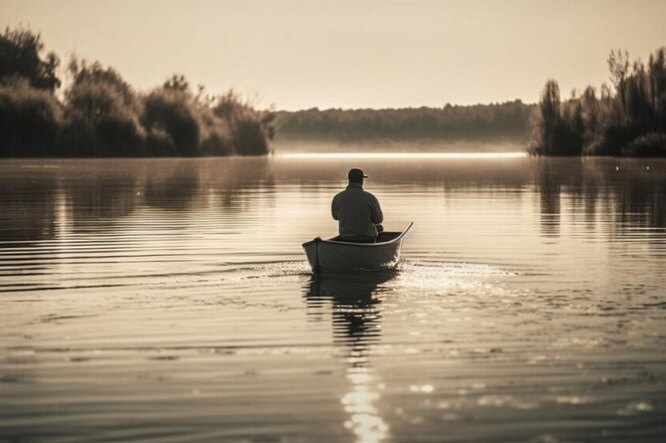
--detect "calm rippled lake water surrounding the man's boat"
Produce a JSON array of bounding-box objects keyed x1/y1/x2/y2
[{"x1": 0, "y1": 155, "x2": 666, "y2": 442}]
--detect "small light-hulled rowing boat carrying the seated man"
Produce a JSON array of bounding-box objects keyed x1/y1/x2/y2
[{"x1": 303, "y1": 222, "x2": 414, "y2": 274}]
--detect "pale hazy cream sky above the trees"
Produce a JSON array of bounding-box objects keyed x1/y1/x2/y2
[{"x1": 0, "y1": 0, "x2": 666, "y2": 109}]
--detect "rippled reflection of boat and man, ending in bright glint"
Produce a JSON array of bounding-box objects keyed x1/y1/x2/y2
[{"x1": 306, "y1": 270, "x2": 398, "y2": 442}]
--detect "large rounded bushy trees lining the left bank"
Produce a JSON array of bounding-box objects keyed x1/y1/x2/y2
[{"x1": 0, "y1": 28, "x2": 275, "y2": 157}]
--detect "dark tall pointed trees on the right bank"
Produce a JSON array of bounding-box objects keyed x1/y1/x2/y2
[{"x1": 529, "y1": 48, "x2": 666, "y2": 156}]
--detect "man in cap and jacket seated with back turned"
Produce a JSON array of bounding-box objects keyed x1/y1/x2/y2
[{"x1": 331, "y1": 168, "x2": 384, "y2": 243}]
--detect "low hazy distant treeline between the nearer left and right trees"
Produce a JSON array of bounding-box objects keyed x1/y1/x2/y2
[{"x1": 276, "y1": 100, "x2": 534, "y2": 141}]
